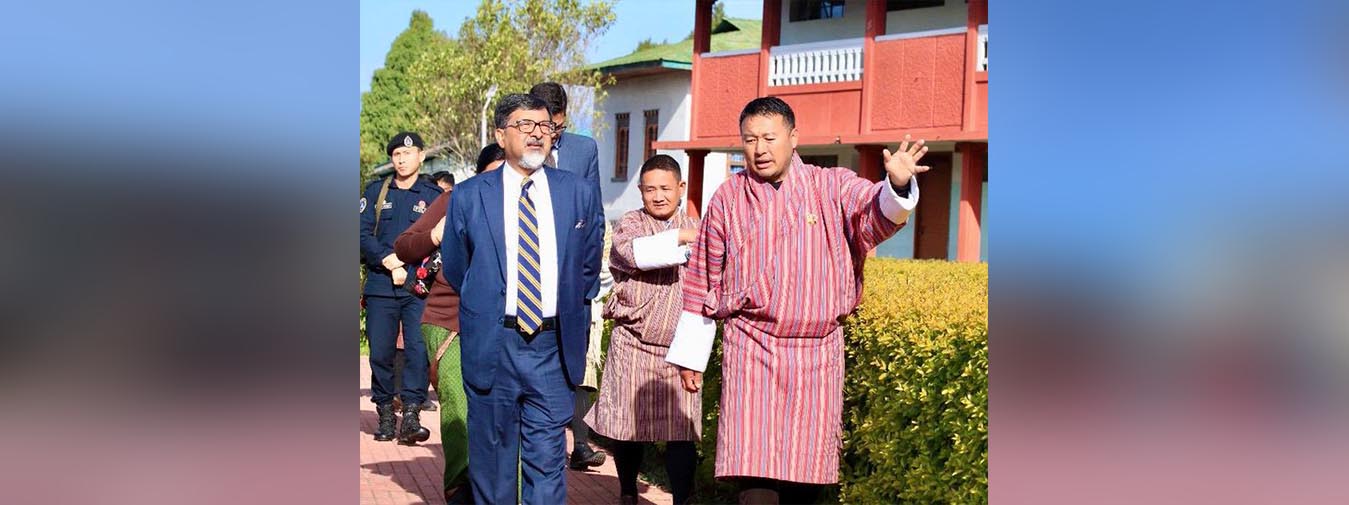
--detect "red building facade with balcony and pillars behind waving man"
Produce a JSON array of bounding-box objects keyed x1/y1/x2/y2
[{"x1": 654, "y1": 0, "x2": 989, "y2": 261}]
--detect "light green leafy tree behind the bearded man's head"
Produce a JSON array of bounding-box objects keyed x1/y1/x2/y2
[{"x1": 409, "y1": 0, "x2": 615, "y2": 169}]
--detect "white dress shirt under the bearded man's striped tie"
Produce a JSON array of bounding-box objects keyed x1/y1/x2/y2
[{"x1": 500, "y1": 163, "x2": 557, "y2": 317}]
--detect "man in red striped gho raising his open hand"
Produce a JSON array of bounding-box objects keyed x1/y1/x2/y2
[{"x1": 665, "y1": 96, "x2": 928, "y2": 504}]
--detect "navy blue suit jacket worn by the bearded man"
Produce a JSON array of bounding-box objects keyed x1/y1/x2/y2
[{"x1": 440, "y1": 165, "x2": 604, "y2": 390}]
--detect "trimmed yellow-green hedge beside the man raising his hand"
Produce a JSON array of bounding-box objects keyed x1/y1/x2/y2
[{"x1": 604, "y1": 258, "x2": 989, "y2": 504}]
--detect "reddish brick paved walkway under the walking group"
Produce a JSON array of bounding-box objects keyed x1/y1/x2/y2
[{"x1": 360, "y1": 356, "x2": 670, "y2": 505}]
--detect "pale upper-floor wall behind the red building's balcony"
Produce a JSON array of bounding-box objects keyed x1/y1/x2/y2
[{"x1": 778, "y1": 0, "x2": 966, "y2": 46}]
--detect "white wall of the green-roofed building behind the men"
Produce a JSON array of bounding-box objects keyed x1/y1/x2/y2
[{"x1": 595, "y1": 72, "x2": 726, "y2": 220}]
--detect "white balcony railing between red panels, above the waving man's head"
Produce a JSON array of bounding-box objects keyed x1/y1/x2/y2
[{"x1": 768, "y1": 39, "x2": 862, "y2": 86}]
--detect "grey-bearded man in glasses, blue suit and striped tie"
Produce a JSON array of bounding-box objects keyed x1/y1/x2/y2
[{"x1": 441, "y1": 95, "x2": 604, "y2": 504}]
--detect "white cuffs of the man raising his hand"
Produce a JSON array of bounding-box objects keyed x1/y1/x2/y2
[{"x1": 665, "y1": 176, "x2": 919, "y2": 371}]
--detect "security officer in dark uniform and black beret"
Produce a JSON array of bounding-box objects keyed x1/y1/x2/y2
[{"x1": 360, "y1": 131, "x2": 441, "y2": 446}]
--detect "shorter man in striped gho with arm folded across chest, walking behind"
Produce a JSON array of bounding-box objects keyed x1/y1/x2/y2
[{"x1": 585, "y1": 154, "x2": 703, "y2": 505}]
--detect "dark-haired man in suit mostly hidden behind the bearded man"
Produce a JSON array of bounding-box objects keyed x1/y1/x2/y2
[{"x1": 529, "y1": 82, "x2": 604, "y2": 470}]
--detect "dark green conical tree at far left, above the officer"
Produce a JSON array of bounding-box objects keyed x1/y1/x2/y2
[{"x1": 360, "y1": 11, "x2": 449, "y2": 181}]
